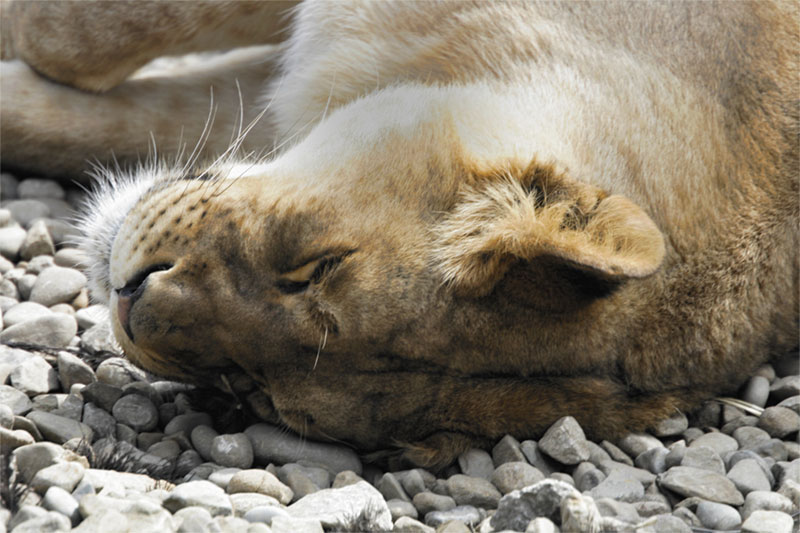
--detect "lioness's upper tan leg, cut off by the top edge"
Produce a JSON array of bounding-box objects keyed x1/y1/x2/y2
[{"x1": 0, "y1": 0, "x2": 296, "y2": 92}]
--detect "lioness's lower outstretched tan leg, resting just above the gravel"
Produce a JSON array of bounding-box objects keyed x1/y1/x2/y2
[{"x1": 0, "y1": 47, "x2": 282, "y2": 181}]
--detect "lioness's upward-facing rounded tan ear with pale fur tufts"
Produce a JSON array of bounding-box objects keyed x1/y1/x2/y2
[{"x1": 435, "y1": 165, "x2": 664, "y2": 296}]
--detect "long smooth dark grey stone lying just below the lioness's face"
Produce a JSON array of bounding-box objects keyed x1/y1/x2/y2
[{"x1": 242, "y1": 420, "x2": 362, "y2": 474}]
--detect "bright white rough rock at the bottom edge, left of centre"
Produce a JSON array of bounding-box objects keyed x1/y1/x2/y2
[{"x1": 286, "y1": 481, "x2": 392, "y2": 531}]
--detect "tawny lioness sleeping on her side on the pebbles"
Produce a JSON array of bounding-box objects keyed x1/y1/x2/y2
[{"x1": 2, "y1": 1, "x2": 800, "y2": 467}]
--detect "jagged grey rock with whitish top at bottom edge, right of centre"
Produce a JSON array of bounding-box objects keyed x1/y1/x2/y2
[{"x1": 491, "y1": 479, "x2": 578, "y2": 531}]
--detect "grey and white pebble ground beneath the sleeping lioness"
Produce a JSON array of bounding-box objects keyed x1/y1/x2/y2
[{"x1": 0, "y1": 174, "x2": 800, "y2": 533}]
